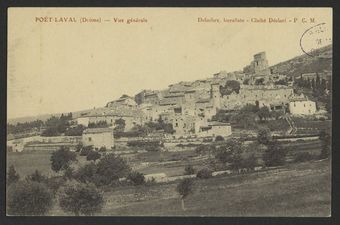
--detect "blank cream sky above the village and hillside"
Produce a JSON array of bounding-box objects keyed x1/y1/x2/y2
[{"x1": 7, "y1": 8, "x2": 332, "y2": 118}]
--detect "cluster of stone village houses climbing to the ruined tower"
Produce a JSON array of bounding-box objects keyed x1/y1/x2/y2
[{"x1": 6, "y1": 52, "x2": 322, "y2": 152}]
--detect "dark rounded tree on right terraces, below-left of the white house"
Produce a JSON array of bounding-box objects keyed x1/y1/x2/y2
[{"x1": 263, "y1": 141, "x2": 287, "y2": 166}]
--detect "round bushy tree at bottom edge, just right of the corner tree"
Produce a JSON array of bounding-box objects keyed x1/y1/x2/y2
[{"x1": 59, "y1": 183, "x2": 104, "y2": 216}]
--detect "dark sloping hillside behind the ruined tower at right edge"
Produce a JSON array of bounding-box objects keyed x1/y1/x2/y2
[{"x1": 270, "y1": 45, "x2": 333, "y2": 76}]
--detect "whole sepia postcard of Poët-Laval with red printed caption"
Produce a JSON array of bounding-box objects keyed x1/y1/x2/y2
[{"x1": 6, "y1": 7, "x2": 333, "y2": 217}]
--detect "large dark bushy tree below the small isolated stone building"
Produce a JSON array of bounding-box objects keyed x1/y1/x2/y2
[{"x1": 97, "y1": 153, "x2": 131, "y2": 185}]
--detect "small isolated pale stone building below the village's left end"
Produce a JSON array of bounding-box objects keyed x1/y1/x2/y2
[{"x1": 82, "y1": 128, "x2": 114, "y2": 149}]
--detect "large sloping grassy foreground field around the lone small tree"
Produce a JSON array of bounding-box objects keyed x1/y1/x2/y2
[{"x1": 97, "y1": 161, "x2": 331, "y2": 217}]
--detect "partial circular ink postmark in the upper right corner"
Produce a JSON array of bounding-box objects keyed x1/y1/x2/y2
[{"x1": 300, "y1": 23, "x2": 332, "y2": 59}]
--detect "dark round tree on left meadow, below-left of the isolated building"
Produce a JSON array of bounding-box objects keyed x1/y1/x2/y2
[{"x1": 50, "y1": 146, "x2": 77, "y2": 172}]
